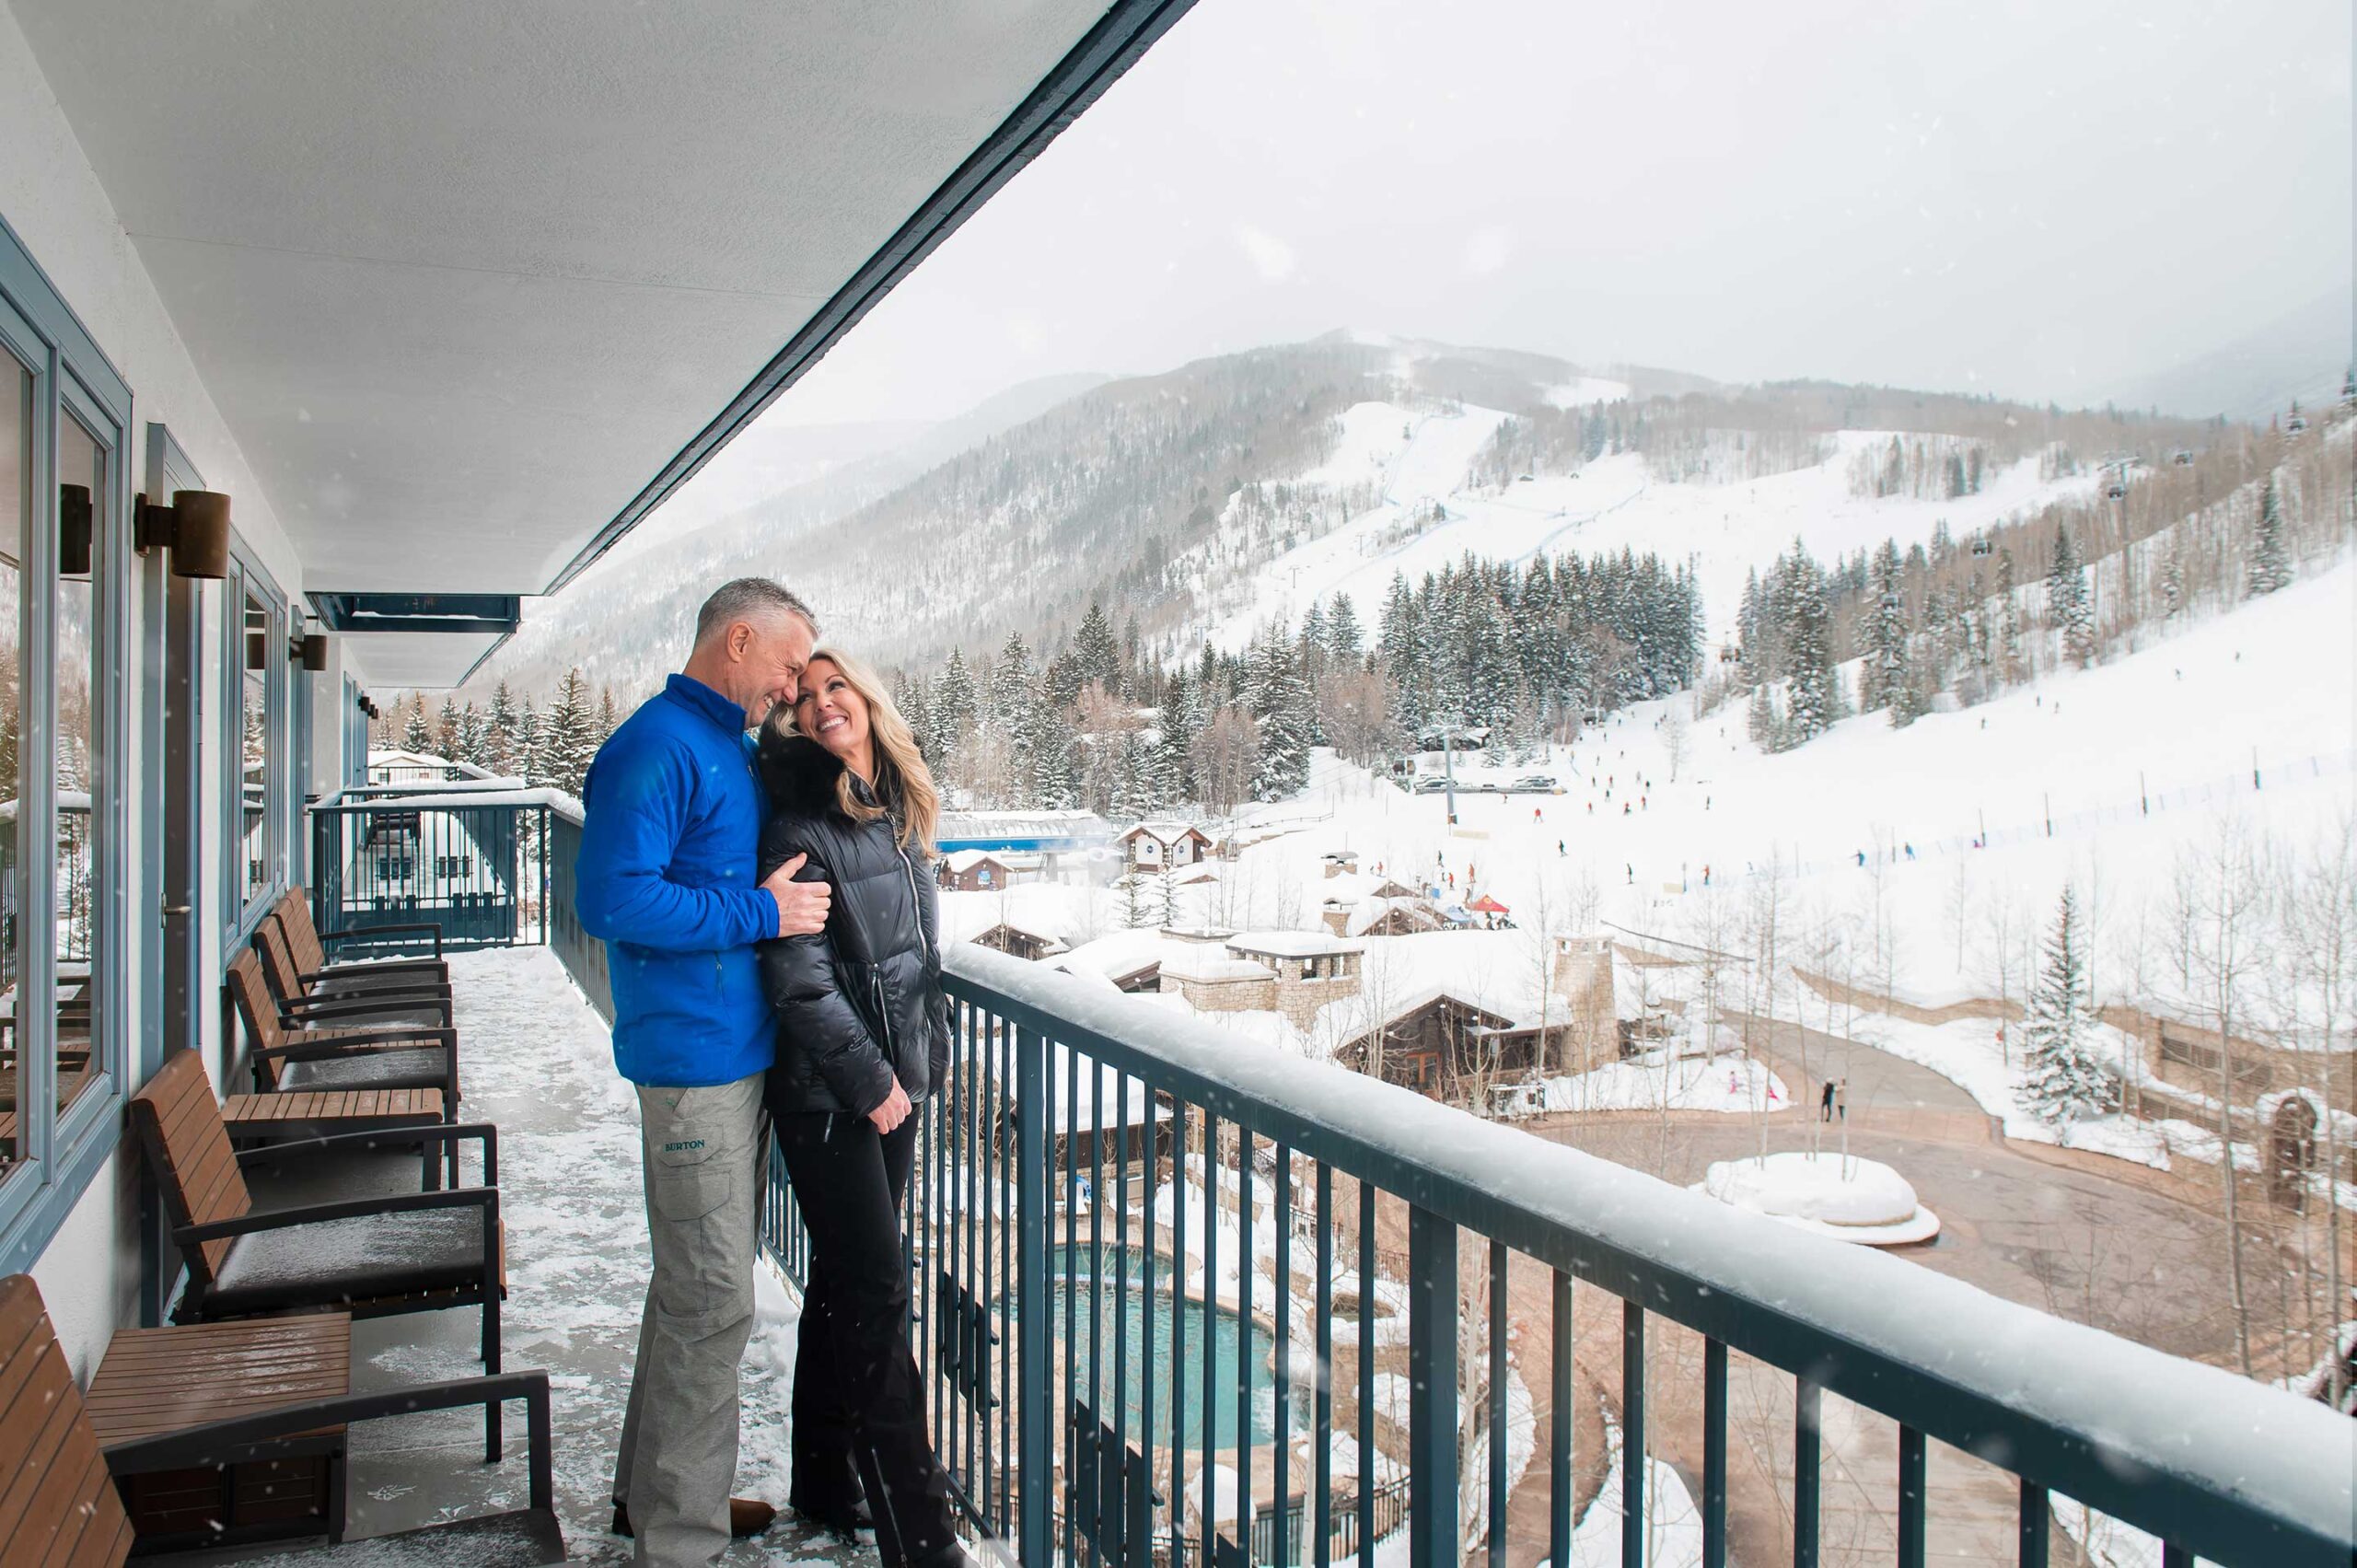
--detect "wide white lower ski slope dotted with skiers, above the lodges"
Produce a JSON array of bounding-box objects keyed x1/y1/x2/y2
[{"x1": 1197, "y1": 549, "x2": 2357, "y2": 1002}]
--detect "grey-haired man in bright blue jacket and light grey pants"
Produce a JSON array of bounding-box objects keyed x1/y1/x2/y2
[{"x1": 575, "y1": 577, "x2": 830, "y2": 1568}]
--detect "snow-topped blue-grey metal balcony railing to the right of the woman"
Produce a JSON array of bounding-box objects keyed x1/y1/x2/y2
[{"x1": 910, "y1": 946, "x2": 2357, "y2": 1568}]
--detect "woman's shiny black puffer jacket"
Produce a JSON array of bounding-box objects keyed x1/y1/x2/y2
[{"x1": 761, "y1": 726, "x2": 950, "y2": 1115}]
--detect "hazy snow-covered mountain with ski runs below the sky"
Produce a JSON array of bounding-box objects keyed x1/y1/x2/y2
[{"x1": 476, "y1": 332, "x2": 2244, "y2": 693}]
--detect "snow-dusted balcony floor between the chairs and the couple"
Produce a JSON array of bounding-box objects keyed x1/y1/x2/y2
[{"x1": 327, "y1": 947, "x2": 853, "y2": 1565}]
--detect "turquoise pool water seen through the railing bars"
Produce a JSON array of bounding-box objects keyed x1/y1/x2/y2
[{"x1": 1049, "y1": 1245, "x2": 1275, "y2": 1450}]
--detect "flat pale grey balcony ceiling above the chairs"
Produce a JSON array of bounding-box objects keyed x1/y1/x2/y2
[{"x1": 7, "y1": 0, "x2": 1159, "y2": 674}]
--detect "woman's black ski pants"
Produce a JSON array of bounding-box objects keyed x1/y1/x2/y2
[{"x1": 773, "y1": 1110, "x2": 957, "y2": 1568}]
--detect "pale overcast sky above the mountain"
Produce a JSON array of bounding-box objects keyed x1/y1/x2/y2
[{"x1": 771, "y1": 0, "x2": 2352, "y2": 424}]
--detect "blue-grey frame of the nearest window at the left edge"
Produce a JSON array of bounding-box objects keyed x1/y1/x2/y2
[{"x1": 0, "y1": 219, "x2": 136, "y2": 1273}]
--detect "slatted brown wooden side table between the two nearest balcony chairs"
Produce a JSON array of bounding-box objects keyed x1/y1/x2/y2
[{"x1": 85, "y1": 1311, "x2": 351, "y2": 1551}]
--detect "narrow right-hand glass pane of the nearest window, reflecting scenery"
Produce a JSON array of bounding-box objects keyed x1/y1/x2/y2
[{"x1": 52, "y1": 415, "x2": 109, "y2": 1109}]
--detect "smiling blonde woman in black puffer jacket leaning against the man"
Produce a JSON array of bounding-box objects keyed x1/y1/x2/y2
[{"x1": 761, "y1": 651, "x2": 964, "y2": 1568}]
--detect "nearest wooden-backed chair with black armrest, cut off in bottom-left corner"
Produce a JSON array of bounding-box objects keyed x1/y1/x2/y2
[{"x1": 0, "y1": 1273, "x2": 565, "y2": 1568}]
